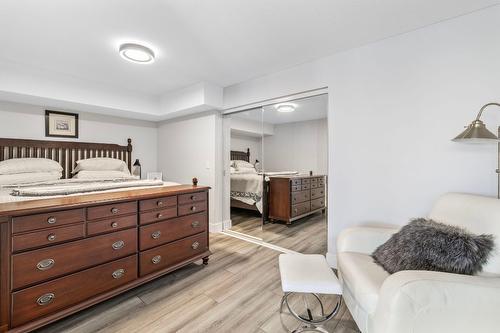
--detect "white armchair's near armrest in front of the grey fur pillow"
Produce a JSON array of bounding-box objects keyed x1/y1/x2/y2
[{"x1": 368, "y1": 271, "x2": 500, "y2": 333}]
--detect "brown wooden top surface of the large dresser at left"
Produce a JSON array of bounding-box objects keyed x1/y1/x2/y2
[{"x1": 0, "y1": 185, "x2": 210, "y2": 217}]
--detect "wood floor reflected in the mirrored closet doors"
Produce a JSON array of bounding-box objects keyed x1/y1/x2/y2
[{"x1": 231, "y1": 208, "x2": 327, "y2": 254}]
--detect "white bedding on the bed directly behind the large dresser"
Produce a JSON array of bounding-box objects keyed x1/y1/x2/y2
[{"x1": 0, "y1": 179, "x2": 180, "y2": 203}]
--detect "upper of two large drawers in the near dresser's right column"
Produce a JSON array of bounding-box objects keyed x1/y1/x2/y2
[{"x1": 139, "y1": 212, "x2": 207, "y2": 251}]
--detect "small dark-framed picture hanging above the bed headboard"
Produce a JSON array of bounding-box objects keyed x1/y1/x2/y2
[{"x1": 45, "y1": 110, "x2": 78, "y2": 138}]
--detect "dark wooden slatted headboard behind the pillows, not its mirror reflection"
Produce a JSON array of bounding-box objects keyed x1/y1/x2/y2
[{"x1": 0, "y1": 138, "x2": 132, "y2": 179}]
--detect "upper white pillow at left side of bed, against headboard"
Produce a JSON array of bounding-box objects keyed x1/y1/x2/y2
[{"x1": 0, "y1": 158, "x2": 62, "y2": 175}]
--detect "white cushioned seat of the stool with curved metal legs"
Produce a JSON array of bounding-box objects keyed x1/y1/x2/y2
[{"x1": 279, "y1": 253, "x2": 342, "y2": 295}]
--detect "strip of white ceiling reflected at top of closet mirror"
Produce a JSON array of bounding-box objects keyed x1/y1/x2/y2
[{"x1": 231, "y1": 94, "x2": 328, "y2": 125}]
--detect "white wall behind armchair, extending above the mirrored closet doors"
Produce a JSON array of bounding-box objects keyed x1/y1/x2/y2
[{"x1": 224, "y1": 6, "x2": 500, "y2": 261}]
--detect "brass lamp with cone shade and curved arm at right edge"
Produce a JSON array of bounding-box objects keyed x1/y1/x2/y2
[{"x1": 452, "y1": 103, "x2": 500, "y2": 199}]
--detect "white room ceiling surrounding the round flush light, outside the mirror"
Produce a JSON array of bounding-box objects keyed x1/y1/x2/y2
[{"x1": 0, "y1": 0, "x2": 498, "y2": 96}]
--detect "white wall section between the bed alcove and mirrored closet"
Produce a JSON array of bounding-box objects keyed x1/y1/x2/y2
[{"x1": 154, "y1": 112, "x2": 222, "y2": 231}]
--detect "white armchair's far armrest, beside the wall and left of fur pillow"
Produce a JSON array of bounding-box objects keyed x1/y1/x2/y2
[{"x1": 337, "y1": 226, "x2": 399, "y2": 254}]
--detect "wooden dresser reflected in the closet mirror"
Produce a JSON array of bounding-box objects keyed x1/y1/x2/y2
[{"x1": 269, "y1": 176, "x2": 326, "y2": 224}]
